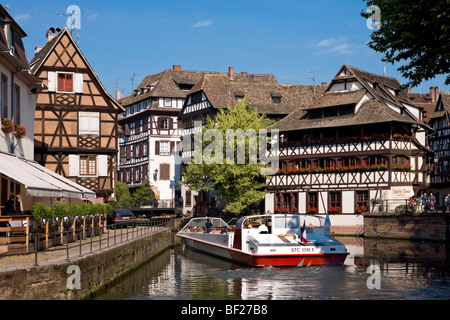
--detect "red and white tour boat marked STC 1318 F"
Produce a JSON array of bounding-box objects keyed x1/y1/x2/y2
[{"x1": 177, "y1": 214, "x2": 348, "y2": 267}]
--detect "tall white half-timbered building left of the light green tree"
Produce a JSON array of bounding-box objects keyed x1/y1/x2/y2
[{"x1": 118, "y1": 65, "x2": 219, "y2": 205}]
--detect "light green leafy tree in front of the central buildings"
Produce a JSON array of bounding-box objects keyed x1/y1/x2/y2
[{"x1": 181, "y1": 99, "x2": 272, "y2": 215}]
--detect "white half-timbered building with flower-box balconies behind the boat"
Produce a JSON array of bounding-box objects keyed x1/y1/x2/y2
[{"x1": 266, "y1": 65, "x2": 432, "y2": 213}]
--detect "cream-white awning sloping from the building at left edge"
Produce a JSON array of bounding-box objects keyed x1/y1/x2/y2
[{"x1": 0, "y1": 153, "x2": 96, "y2": 198}]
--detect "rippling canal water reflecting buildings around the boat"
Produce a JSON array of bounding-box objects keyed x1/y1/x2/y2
[{"x1": 95, "y1": 237, "x2": 450, "y2": 300}]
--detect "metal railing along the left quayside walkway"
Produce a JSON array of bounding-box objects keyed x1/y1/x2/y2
[{"x1": 30, "y1": 217, "x2": 171, "y2": 266}]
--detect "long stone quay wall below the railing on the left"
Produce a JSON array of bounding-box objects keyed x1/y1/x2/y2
[{"x1": 0, "y1": 228, "x2": 173, "y2": 300}]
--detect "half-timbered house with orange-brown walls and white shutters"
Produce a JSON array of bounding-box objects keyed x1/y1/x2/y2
[{"x1": 30, "y1": 28, "x2": 123, "y2": 201}]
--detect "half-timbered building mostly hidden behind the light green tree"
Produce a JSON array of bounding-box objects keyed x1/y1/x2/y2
[{"x1": 178, "y1": 67, "x2": 326, "y2": 215}]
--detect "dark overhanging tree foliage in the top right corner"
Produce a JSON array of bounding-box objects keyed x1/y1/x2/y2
[{"x1": 361, "y1": 0, "x2": 450, "y2": 87}]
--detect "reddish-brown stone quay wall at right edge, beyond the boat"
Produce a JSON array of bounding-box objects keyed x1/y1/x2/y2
[{"x1": 364, "y1": 212, "x2": 449, "y2": 241}]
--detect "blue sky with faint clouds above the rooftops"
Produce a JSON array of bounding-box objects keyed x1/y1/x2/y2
[{"x1": 7, "y1": 0, "x2": 450, "y2": 96}]
